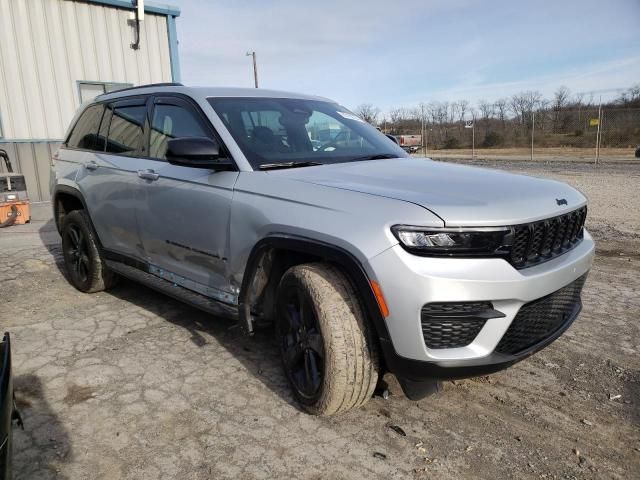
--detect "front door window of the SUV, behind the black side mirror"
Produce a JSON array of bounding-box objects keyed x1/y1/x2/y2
[{"x1": 149, "y1": 104, "x2": 209, "y2": 159}]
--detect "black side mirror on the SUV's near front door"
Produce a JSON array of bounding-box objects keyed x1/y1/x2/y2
[{"x1": 167, "y1": 137, "x2": 236, "y2": 171}]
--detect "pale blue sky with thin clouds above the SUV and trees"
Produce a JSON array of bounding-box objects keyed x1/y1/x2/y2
[{"x1": 168, "y1": 0, "x2": 640, "y2": 109}]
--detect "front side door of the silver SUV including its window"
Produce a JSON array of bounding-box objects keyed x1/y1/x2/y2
[{"x1": 138, "y1": 95, "x2": 238, "y2": 303}]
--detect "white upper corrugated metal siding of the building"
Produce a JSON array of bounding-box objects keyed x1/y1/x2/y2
[{"x1": 0, "y1": 0, "x2": 171, "y2": 140}]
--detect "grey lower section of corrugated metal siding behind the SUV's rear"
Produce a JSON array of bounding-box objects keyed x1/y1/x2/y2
[{"x1": 0, "y1": 142, "x2": 60, "y2": 202}]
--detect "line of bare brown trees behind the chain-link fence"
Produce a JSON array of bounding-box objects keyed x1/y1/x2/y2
[{"x1": 354, "y1": 83, "x2": 640, "y2": 148}]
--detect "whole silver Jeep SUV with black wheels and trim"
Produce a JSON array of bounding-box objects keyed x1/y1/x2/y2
[{"x1": 51, "y1": 84, "x2": 594, "y2": 415}]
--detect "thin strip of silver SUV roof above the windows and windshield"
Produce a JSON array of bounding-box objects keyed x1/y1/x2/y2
[{"x1": 98, "y1": 84, "x2": 332, "y2": 102}]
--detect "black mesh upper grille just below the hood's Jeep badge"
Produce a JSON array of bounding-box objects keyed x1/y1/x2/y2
[{"x1": 509, "y1": 207, "x2": 587, "y2": 269}]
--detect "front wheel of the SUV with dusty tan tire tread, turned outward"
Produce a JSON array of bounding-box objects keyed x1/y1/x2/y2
[{"x1": 276, "y1": 263, "x2": 379, "y2": 416}]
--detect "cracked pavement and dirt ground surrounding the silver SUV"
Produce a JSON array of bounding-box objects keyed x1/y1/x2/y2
[{"x1": 0, "y1": 162, "x2": 640, "y2": 480}]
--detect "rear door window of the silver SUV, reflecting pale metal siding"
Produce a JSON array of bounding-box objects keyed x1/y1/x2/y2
[{"x1": 106, "y1": 105, "x2": 147, "y2": 156}]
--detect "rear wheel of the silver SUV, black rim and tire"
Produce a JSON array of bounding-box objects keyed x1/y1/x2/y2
[{"x1": 61, "y1": 210, "x2": 118, "y2": 293}]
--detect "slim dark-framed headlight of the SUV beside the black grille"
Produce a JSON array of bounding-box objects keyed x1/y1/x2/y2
[{"x1": 391, "y1": 225, "x2": 513, "y2": 256}]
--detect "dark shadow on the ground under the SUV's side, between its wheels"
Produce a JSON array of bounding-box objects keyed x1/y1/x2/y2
[{"x1": 107, "y1": 278, "x2": 299, "y2": 409}]
